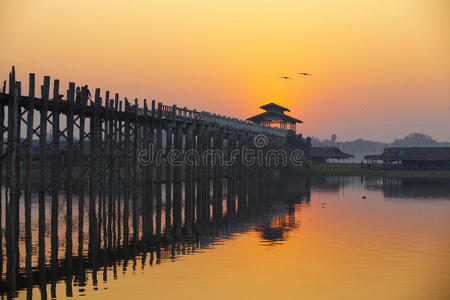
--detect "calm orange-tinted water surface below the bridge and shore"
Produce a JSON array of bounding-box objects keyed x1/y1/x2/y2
[{"x1": 2, "y1": 177, "x2": 450, "y2": 299}]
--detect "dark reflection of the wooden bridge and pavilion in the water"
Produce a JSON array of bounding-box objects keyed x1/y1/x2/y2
[{"x1": 0, "y1": 176, "x2": 310, "y2": 299}]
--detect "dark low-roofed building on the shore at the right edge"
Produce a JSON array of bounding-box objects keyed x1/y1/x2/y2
[{"x1": 364, "y1": 147, "x2": 450, "y2": 170}]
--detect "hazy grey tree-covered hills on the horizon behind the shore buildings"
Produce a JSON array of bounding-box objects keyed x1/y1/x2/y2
[{"x1": 311, "y1": 133, "x2": 450, "y2": 162}]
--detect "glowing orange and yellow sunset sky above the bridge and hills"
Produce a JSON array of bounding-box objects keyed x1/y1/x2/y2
[{"x1": 0, "y1": 0, "x2": 450, "y2": 141}]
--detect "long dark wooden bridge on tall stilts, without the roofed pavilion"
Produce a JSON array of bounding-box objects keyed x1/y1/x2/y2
[{"x1": 0, "y1": 67, "x2": 306, "y2": 298}]
